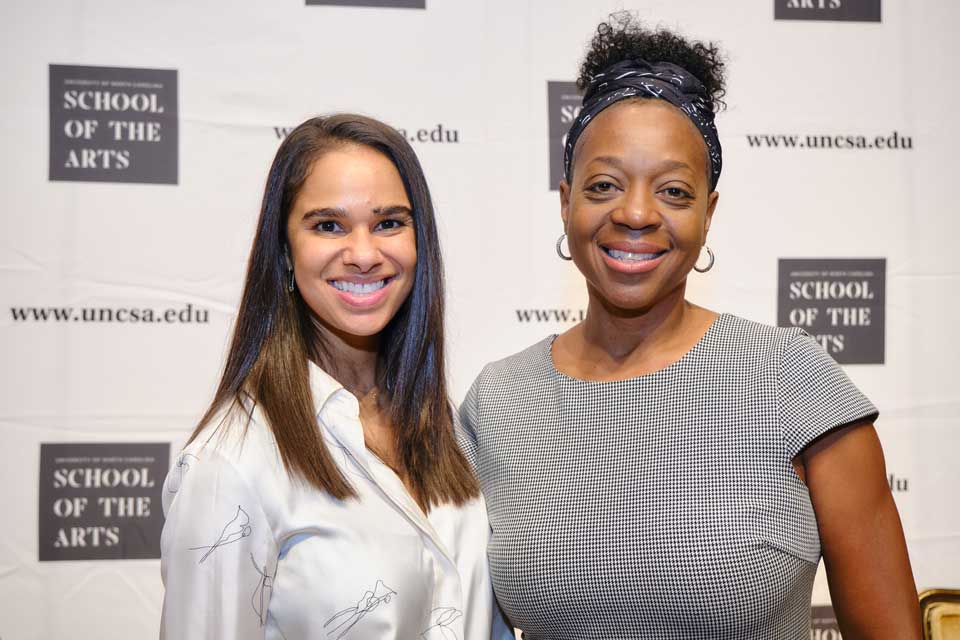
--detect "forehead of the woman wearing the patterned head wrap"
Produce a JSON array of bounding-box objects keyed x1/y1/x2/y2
[{"x1": 574, "y1": 99, "x2": 707, "y2": 174}]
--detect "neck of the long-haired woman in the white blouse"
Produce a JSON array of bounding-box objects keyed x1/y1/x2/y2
[{"x1": 313, "y1": 320, "x2": 380, "y2": 398}]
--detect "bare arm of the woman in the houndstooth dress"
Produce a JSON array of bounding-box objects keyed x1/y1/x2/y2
[{"x1": 794, "y1": 422, "x2": 921, "y2": 640}]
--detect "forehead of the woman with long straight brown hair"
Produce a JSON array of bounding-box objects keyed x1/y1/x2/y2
[{"x1": 294, "y1": 144, "x2": 409, "y2": 208}]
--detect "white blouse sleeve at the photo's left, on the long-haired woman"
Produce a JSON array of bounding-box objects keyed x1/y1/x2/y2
[{"x1": 160, "y1": 447, "x2": 278, "y2": 640}]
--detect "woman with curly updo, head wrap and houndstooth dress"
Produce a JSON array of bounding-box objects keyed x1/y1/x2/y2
[{"x1": 461, "y1": 15, "x2": 920, "y2": 640}]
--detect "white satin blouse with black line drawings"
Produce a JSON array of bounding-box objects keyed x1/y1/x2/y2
[{"x1": 160, "y1": 364, "x2": 513, "y2": 640}]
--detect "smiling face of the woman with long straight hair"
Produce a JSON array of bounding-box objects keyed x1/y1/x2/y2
[{"x1": 287, "y1": 144, "x2": 417, "y2": 340}]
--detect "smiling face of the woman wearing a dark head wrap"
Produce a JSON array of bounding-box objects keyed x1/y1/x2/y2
[{"x1": 560, "y1": 100, "x2": 718, "y2": 314}]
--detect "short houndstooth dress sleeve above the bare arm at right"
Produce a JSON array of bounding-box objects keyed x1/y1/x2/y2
[{"x1": 777, "y1": 332, "x2": 878, "y2": 460}]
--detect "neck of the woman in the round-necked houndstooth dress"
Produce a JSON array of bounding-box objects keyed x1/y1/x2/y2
[{"x1": 582, "y1": 281, "x2": 697, "y2": 362}]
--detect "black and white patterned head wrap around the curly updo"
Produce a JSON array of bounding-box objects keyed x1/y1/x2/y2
[{"x1": 563, "y1": 60, "x2": 723, "y2": 190}]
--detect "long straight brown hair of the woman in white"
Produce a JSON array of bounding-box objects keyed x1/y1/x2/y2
[{"x1": 190, "y1": 114, "x2": 479, "y2": 507}]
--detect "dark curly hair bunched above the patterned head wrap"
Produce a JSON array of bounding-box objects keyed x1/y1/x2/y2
[{"x1": 577, "y1": 11, "x2": 726, "y2": 113}]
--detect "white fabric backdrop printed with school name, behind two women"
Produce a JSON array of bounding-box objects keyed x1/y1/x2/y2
[{"x1": 0, "y1": 0, "x2": 960, "y2": 640}]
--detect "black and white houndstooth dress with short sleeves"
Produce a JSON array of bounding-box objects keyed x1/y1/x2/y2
[{"x1": 460, "y1": 314, "x2": 877, "y2": 640}]
